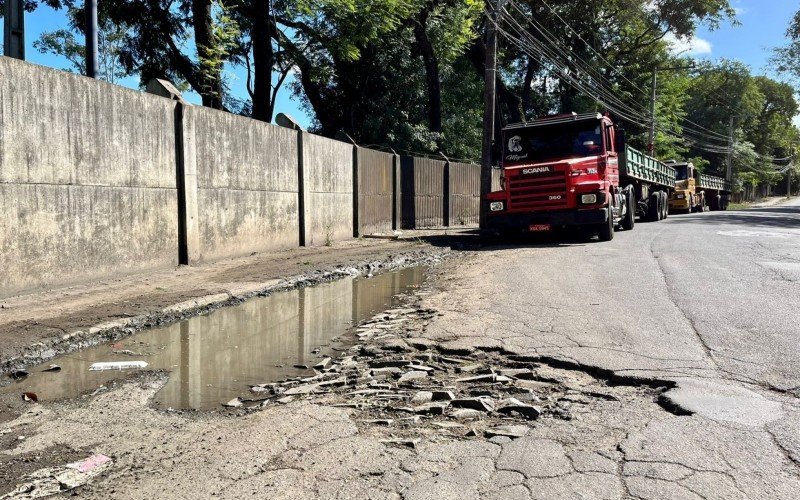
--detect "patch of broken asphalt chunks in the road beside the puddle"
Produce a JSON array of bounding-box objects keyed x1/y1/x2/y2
[{"x1": 223, "y1": 290, "x2": 628, "y2": 448}]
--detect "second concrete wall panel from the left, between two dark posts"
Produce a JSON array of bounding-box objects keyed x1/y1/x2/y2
[{"x1": 192, "y1": 107, "x2": 300, "y2": 260}]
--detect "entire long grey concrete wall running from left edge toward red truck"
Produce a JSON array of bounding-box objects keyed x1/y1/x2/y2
[{"x1": 0, "y1": 57, "x2": 477, "y2": 297}]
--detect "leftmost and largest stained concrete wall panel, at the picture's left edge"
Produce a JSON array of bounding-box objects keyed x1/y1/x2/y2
[{"x1": 0, "y1": 57, "x2": 177, "y2": 296}]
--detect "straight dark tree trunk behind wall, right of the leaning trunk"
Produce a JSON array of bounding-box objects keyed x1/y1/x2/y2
[{"x1": 251, "y1": 0, "x2": 275, "y2": 122}]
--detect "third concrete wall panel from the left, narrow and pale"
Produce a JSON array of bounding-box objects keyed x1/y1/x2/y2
[{"x1": 302, "y1": 133, "x2": 353, "y2": 246}]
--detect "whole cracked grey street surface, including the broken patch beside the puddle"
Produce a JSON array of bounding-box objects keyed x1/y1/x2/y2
[{"x1": 0, "y1": 200, "x2": 800, "y2": 499}]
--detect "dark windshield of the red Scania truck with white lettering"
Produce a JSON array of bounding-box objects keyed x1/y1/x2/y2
[{"x1": 504, "y1": 122, "x2": 603, "y2": 162}]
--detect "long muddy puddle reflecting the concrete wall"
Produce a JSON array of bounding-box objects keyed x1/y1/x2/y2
[{"x1": 0, "y1": 267, "x2": 425, "y2": 409}]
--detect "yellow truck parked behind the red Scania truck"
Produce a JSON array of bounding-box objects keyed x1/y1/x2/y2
[{"x1": 664, "y1": 160, "x2": 731, "y2": 213}]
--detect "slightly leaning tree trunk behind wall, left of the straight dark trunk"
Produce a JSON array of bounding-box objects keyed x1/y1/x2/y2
[{"x1": 192, "y1": 0, "x2": 222, "y2": 109}]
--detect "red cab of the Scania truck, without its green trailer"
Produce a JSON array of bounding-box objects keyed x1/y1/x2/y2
[{"x1": 486, "y1": 113, "x2": 625, "y2": 239}]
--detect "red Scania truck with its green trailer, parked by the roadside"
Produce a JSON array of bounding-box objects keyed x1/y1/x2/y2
[{"x1": 484, "y1": 113, "x2": 675, "y2": 241}]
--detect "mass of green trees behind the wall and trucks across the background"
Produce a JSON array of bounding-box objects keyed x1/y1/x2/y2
[{"x1": 10, "y1": 0, "x2": 800, "y2": 194}]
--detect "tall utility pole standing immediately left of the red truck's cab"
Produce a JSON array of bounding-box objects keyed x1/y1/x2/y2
[{"x1": 479, "y1": 0, "x2": 503, "y2": 228}]
